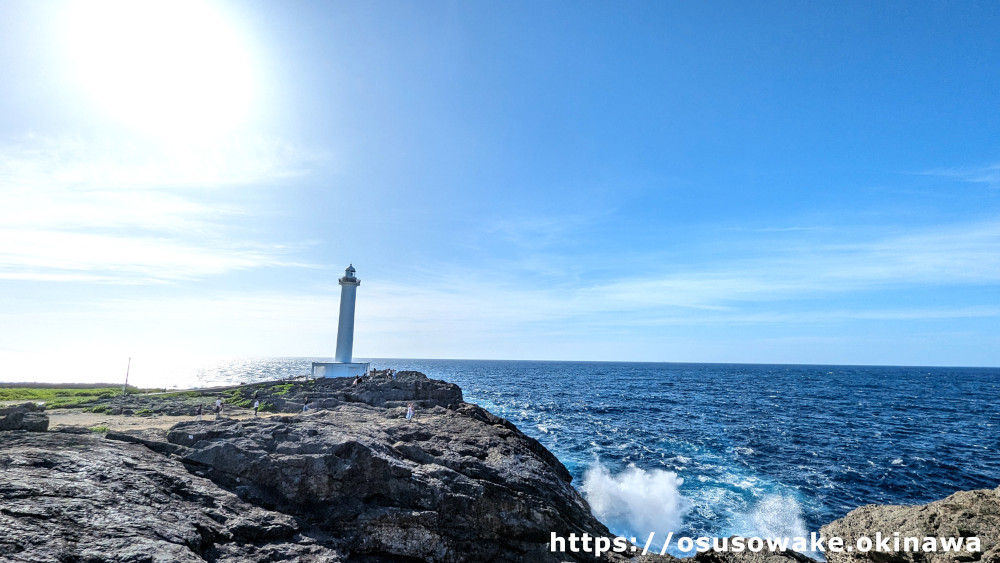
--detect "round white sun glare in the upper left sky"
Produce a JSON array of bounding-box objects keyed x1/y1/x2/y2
[{"x1": 67, "y1": 0, "x2": 254, "y2": 138}]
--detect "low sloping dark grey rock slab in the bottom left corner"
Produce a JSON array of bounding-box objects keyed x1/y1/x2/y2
[{"x1": 0, "y1": 432, "x2": 342, "y2": 563}]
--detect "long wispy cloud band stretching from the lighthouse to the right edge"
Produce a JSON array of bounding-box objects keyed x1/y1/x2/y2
[{"x1": 340, "y1": 216, "x2": 1000, "y2": 348}]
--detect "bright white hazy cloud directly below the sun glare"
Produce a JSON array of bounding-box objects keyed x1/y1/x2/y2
[{"x1": 0, "y1": 137, "x2": 321, "y2": 283}]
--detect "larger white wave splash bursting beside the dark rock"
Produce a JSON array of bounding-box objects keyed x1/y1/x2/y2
[{"x1": 581, "y1": 462, "x2": 691, "y2": 536}]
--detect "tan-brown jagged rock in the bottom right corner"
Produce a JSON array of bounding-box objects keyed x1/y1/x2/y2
[{"x1": 820, "y1": 487, "x2": 1000, "y2": 563}]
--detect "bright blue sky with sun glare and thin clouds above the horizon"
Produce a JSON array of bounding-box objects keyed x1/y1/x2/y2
[{"x1": 0, "y1": 0, "x2": 1000, "y2": 379}]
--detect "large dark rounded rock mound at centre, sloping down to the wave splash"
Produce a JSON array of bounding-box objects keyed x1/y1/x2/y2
[{"x1": 168, "y1": 403, "x2": 609, "y2": 562}]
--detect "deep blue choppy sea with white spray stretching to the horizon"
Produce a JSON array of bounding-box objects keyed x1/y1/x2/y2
[{"x1": 107, "y1": 358, "x2": 1000, "y2": 552}]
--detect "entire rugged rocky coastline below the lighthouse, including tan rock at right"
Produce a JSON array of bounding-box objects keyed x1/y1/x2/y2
[{"x1": 0, "y1": 372, "x2": 1000, "y2": 563}]
